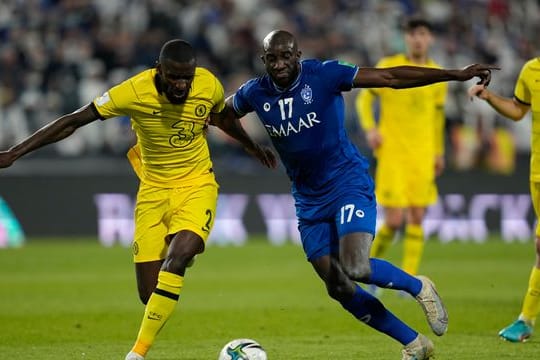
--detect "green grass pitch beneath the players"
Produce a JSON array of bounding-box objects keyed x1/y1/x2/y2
[{"x1": 0, "y1": 239, "x2": 540, "y2": 360}]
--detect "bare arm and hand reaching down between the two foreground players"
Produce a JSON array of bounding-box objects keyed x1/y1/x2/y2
[{"x1": 210, "y1": 98, "x2": 277, "y2": 169}]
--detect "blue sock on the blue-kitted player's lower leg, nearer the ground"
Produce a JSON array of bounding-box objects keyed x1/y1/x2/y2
[{"x1": 341, "y1": 285, "x2": 418, "y2": 345}]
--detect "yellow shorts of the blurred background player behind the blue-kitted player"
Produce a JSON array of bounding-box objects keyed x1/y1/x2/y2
[{"x1": 375, "y1": 159, "x2": 438, "y2": 208}]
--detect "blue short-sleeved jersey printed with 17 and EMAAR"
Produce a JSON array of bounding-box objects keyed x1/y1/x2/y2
[{"x1": 233, "y1": 59, "x2": 368, "y2": 201}]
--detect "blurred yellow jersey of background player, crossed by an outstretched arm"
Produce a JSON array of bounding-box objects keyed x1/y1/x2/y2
[{"x1": 356, "y1": 54, "x2": 448, "y2": 164}]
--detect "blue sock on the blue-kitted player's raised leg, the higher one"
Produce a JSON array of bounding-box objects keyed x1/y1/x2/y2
[{"x1": 369, "y1": 258, "x2": 422, "y2": 296}]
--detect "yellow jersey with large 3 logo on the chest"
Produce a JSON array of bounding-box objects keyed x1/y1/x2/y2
[{"x1": 94, "y1": 67, "x2": 225, "y2": 188}]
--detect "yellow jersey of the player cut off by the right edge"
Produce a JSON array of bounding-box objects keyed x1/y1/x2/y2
[{"x1": 514, "y1": 57, "x2": 540, "y2": 182}]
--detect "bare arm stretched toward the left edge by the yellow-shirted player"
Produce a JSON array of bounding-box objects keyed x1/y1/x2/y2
[{"x1": 0, "y1": 104, "x2": 99, "y2": 168}]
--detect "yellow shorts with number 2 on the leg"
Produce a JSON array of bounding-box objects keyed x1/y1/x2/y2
[{"x1": 133, "y1": 182, "x2": 218, "y2": 263}]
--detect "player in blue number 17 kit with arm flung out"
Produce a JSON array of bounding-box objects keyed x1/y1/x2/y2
[{"x1": 212, "y1": 30, "x2": 496, "y2": 360}]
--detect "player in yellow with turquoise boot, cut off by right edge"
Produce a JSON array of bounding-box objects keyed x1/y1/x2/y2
[{"x1": 469, "y1": 57, "x2": 540, "y2": 342}]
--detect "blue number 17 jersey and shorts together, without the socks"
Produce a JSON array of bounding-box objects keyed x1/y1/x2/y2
[{"x1": 233, "y1": 60, "x2": 377, "y2": 260}]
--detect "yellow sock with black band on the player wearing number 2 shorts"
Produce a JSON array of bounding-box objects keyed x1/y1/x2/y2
[{"x1": 132, "y1": 271, "x2": 184, "y2": 356}]
